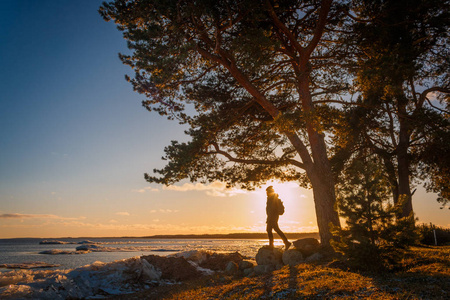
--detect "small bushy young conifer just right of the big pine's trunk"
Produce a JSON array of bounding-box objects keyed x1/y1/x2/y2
[{"x1": 332, "y1": 155, "x2": 417, "y2": 270}]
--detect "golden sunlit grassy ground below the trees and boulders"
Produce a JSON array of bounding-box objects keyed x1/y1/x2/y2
[{"x1": 113, "y1": 246, "x2": 450, "y2": 299}]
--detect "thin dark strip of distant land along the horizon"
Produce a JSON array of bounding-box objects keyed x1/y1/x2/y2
[{"x1": 0, "y1": 232, "x2": 319, "y2": 240}]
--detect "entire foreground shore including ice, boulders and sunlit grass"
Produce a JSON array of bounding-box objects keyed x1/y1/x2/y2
[{"x1": 0, "y1": 243, "x2": 450, "y2": 300}]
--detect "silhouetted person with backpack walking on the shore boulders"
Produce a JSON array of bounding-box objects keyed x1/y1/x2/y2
[{"x1": 266, "y1": 186, "x2": 291, "y2": 250}]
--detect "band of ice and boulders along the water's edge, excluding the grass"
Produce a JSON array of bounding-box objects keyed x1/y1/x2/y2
[{"x1": 0, "y1": 238, "x2": 321, "y2": 299}]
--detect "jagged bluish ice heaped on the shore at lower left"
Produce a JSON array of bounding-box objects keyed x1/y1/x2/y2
[{"x1": 0, "y1": 257, "x2": 161, "y2": 299}]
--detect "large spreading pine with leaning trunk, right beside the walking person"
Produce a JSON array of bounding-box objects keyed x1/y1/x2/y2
[{"x1": 101, "y1": 0, "x2": 348, "y2": 244}]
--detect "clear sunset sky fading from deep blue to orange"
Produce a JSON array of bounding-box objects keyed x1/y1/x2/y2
[{"x1": 0, "y1": 0, "x2": 450, "y2": 238}]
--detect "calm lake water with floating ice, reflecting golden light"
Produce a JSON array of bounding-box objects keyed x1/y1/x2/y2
[{"x1": 0, "y1": 238, "x2": 272, "y2": 272}]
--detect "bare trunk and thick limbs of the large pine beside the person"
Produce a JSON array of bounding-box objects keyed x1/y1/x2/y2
[{"x1": 207, "y1": 0, "x2": 340, "y2": 246}]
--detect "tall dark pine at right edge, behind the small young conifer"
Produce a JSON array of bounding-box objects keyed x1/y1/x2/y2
[{"x1": 351, "y1": 0, "x2": 450, "y2": 216}]
